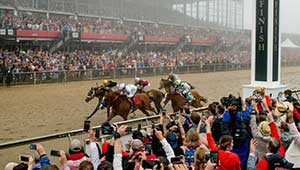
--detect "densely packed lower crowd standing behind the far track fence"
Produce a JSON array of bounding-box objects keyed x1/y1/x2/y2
[{"x1": 0, "y1": 50, "x2": 250, "y2": 73}]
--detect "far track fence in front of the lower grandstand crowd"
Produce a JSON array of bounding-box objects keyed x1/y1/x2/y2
[{"x1": 0, "y1": 64, "x2": 250, "y2": 86}]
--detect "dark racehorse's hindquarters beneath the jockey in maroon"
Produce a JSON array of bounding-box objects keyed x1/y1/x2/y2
[{"x1": 137, "y1": 89, "x2": 165, "y2": 114}]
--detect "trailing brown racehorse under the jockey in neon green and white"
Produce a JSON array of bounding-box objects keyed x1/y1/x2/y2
[{"x1": 159, "y1": 79, "x2": 207, "y2": 112}]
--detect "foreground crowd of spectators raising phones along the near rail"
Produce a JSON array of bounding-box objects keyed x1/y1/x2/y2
[{"x1": 5, "y1": 87, "x2": 300, "y2": 170}]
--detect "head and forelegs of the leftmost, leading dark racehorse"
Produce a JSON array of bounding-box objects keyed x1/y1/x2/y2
[{"x1": 85, "y1": 86, "x2": 109, "y2": 119}]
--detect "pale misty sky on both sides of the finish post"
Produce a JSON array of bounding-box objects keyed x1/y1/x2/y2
[{"x1": 244, "y1": 0, "x2": 300, "y2": 34}]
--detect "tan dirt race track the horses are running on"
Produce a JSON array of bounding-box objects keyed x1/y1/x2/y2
[{"x1": 0, "y1": 67, "x2": 300, "y2": 169}]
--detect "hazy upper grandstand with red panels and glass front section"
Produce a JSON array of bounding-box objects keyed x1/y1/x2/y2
[{"x1": 0, "y1": 0, "x2": 250, "y2": 52}]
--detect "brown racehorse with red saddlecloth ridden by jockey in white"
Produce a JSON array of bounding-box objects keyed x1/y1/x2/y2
[{"x1": 104, "y1": 91, "x2": 155, "y2": 121}]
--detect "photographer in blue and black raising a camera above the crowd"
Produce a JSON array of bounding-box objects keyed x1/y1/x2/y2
[{"x1": 221, "y1": 95, "x2": 251, "y2": 167}]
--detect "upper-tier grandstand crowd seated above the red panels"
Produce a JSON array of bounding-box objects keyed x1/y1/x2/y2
[{"x1": 0, "y1": 13, "x2": 250, "y2": 43}]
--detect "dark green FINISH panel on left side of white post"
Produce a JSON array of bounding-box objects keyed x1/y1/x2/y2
[{"x1": 255, "y1": 0, "x2": 268, "y2": 81}]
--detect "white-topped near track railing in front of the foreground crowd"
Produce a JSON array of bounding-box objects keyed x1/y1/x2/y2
[{"x1": 0, "y1": 115, "x2": 159, "y2": 149}]
